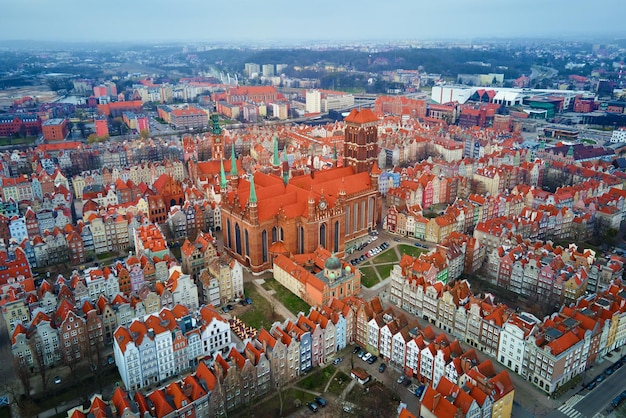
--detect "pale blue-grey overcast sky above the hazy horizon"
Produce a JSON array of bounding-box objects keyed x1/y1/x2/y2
[{"x1": 0, "y1": 0, "x2": 626, "y2": 42}]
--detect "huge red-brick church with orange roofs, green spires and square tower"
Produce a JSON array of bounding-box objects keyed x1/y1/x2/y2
[{"x1": 220, "y1": 109, "x2": 382, "y2": 272}]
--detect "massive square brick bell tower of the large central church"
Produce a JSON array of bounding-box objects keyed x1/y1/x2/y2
[{"x1": 343, "y1": 109, "x2": 378, "y2": 173}]
